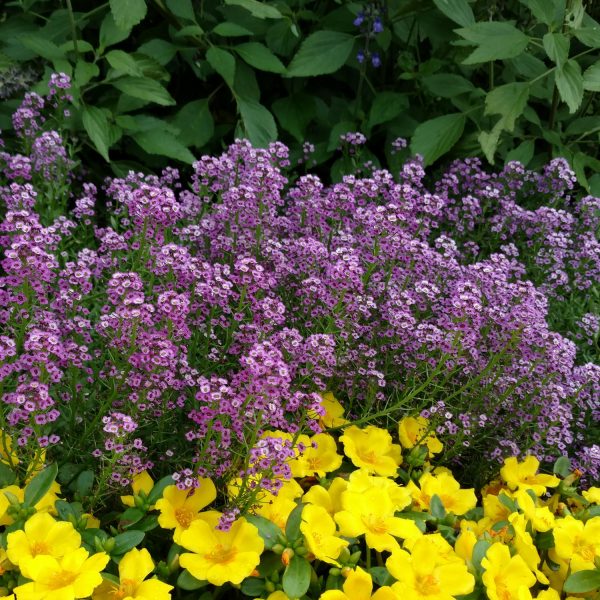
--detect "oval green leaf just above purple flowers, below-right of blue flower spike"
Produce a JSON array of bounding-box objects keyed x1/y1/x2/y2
[{"x1": 410, "y1": 113, "x2": 465, "y2": 166}]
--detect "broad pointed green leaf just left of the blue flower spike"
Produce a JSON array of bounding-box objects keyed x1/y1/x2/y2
[{"x1": 287, "y1": 31, "x2": 354, "y2": 77}]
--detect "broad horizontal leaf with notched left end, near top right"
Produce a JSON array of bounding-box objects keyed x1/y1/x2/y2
[{"x1": 456, "y1": 21, "x2": 529, "y2": 65}]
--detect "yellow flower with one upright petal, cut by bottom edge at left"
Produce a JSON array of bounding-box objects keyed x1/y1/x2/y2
[{"x1": 92, "y1": 548, "x2": 173, "y2": 600}]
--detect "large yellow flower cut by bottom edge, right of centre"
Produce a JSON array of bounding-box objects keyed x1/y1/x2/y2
[{"x1": 386, "y1": 535, "x2": 475, "y2": 600}]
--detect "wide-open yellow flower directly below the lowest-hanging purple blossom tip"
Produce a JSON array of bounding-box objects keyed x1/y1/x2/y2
[{"x1": 178, "y1": 511, "x2": 265, "y2": 586}]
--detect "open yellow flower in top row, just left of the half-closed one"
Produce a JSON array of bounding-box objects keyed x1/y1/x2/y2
[{"x1": 340, "y1": 425, "x2": 402, "y2": 477}]
